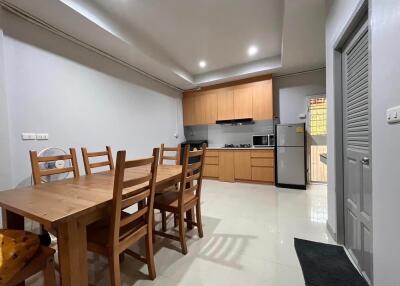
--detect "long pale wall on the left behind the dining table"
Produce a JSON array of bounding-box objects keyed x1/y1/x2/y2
[{"x1": 0, "y1": 10, "x2": 184, "y2": 185}]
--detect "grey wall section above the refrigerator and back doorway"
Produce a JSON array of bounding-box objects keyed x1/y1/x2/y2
[{"x1": 273, "y1": 70, "x2": 325, "y2": 123}]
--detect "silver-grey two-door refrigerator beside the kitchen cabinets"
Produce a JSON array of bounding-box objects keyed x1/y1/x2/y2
[{"x1": 275, "y1": 123, "x2": 307, "y2": 190}]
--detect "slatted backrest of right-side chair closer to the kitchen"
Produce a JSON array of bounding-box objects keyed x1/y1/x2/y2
[{"x1": 178, "y1": 143, "x2": 207, "y2": 206}]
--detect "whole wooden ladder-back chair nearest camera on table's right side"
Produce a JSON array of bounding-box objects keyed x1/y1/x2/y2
[{"x1": 87, "y1": 148, "x2": 159, "y2": 285}]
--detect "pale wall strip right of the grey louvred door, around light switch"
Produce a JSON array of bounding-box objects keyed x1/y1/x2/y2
[{"x1": 371, "y1": 0, "x2": 400, "y2": 286}]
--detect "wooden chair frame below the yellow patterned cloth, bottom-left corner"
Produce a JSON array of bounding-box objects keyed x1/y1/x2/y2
[{"x1": 5, "y1": 246, "x2": 57, "y2": 286}]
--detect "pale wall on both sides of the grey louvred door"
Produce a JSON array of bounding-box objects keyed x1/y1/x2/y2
[{"x1": 326, "y1": 0, "x2": 400, "y2": 286}]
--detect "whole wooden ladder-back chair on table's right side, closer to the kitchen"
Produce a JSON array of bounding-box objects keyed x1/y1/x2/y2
[{"x1": 154, "y1": 144, "x2": 206, "y2": 254}]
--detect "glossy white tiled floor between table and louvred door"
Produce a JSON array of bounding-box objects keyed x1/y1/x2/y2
[{"x1": 28, "y1": 180, "x2": 334, "y2": 286}]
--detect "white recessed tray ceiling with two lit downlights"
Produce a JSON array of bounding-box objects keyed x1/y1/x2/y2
[{"x1": 4, "y1": 0, "x2": 325, "y2": 89}]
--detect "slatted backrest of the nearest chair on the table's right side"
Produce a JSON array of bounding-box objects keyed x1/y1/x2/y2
[{"x1": 109, "y1": 148, "x2": 160, "y2": 248}]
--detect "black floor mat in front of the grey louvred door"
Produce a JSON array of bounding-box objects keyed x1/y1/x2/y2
[{"x1": 294, "y1": 238, "x2": 368, "y2": 286}]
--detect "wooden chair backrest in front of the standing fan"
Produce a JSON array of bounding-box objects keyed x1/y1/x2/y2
[{"x1": 29, "y1": 148, "x2": 79, "y2": 185}]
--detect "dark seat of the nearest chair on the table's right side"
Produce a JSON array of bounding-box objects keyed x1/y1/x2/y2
[{"x1": 87, "y1": 212, "x2": 146, "y2": 253}]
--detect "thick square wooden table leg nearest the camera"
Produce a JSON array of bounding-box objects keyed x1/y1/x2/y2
[{"x1": 58, "y1": 220, "x2": 88, "y2": 286}]
